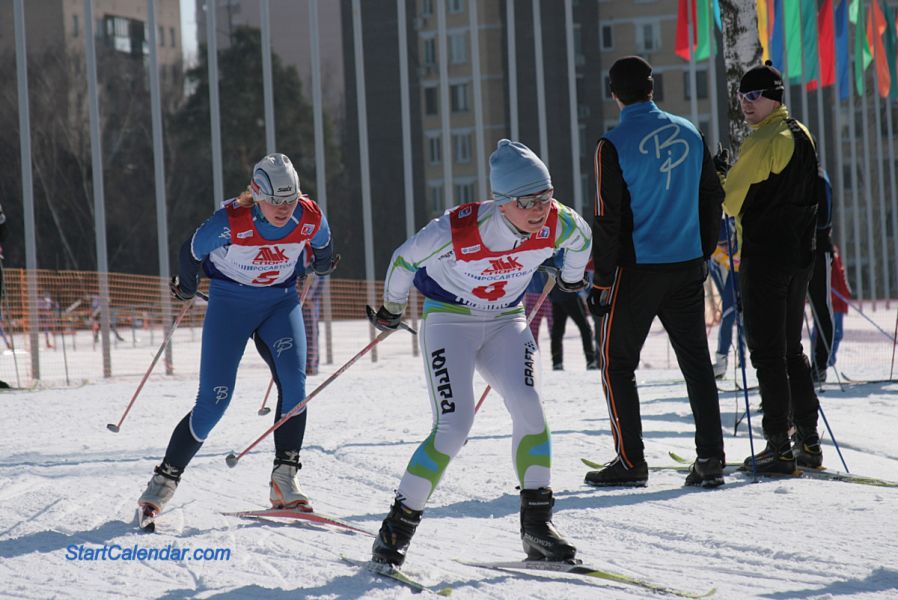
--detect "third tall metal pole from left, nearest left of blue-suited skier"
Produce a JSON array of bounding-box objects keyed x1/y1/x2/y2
[{"x1": 147, "y1": 0, "x2": 173, "y2": 375}]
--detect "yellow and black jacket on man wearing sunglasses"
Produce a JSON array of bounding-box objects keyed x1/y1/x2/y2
[{"x1": 723, "y1": 106, "x2": 820, "y2": 268}]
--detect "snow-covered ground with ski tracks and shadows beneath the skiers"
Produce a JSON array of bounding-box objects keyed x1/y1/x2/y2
[{"x1": 0, "y1": 316, "x2": 898, "y2": 599}]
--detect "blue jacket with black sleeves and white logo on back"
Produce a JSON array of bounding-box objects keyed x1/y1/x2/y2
[{"x1": 593, "y1": 101, "x2": 724, "y2": 288}]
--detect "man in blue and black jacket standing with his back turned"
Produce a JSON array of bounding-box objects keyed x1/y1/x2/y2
[{"x1": 586, "y1": 56, "x2": 724, "y2": 487}]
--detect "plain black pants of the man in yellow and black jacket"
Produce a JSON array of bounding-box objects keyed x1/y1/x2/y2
[{"x1": 739, "y1": 256, "x2": 820, "y2": 439}]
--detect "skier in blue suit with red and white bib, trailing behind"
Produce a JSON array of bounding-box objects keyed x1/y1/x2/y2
[{"x1": 138, "y1": 154, "x2": 339, "y2": 524}]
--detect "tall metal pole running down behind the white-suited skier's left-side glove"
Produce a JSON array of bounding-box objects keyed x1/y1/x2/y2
[{"x1": 352, "y1": 0, "x2": 377, "y2": 362}]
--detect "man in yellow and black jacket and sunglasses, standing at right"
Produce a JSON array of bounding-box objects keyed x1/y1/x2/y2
[{"x1": 723, "y1": 61, "x2": 822, "y2": 473}]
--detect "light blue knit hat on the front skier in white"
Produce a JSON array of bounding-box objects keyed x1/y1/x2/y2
[{"x1": 490, "y1": 139, "x2": 552, "y2": 204}]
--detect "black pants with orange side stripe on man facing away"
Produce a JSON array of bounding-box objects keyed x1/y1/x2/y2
[{"x1": 599, "y1": 263, "x2": 724, "y2": 467}]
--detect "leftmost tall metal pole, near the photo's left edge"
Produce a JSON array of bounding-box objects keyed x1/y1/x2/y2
[{"x1": 7, "y1": 0, "x2": 40, "y2": 380}]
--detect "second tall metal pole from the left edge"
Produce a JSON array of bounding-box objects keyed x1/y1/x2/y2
[{"x1": 84, "y1": 0, "x2": 112, "y2": 377}]
